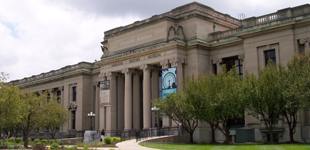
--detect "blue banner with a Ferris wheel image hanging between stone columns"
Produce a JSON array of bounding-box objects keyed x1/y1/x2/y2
[{"x1": 161, "y1": 67, "x2": 178, "y2": 99}]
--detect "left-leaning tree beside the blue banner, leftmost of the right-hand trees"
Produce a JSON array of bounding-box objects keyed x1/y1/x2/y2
[{"x1": 153, "y1": 92, "x2": 198, "y2": 143}]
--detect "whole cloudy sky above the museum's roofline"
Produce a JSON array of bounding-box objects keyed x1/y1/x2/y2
[{"x1": 0, "y1": 0, "x2": 309, "y2": 81}]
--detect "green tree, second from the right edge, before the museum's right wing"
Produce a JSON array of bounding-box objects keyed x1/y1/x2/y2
[{"x1": 245, "y1": 63, "x2": 285, "y2": 142}]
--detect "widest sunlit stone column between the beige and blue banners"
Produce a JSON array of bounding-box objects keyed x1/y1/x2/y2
[{"x1": 140, "y1": 65, "x2": 152, "y2": 129}]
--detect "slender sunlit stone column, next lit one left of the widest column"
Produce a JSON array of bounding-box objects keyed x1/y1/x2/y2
[{"x1": 123, "y1": 68, "x2": 134, "y2": 130}]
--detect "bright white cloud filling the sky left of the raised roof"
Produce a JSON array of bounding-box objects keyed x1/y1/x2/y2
[{"x1": 0, "y1": 1, "x2": 139, "y2": 80}]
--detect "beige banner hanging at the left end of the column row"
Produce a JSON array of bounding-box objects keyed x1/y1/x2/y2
[{"x1": 99, "y1": 80, "x2": 110, "y2": 107}]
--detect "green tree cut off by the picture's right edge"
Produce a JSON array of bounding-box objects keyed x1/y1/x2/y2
[{"x1": 280, "y1": 54, "x2": 310, "y2": 142}]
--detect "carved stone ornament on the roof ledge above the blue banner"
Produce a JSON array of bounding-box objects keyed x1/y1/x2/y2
[{"x1": 167, "y1": 24, "x2": 186, "y2": 42}]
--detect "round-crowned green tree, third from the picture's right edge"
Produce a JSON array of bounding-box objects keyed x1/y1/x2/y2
[{"x1": 202, "y1": 67, "x2": 245, "y2": 143}]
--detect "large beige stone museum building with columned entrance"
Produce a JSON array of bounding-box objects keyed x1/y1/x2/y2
[{"x1": 11, "y1": 2, "x2": 310, "y2": 142}]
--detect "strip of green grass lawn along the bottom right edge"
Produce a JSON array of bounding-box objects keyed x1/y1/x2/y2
[{"x1": 139, "y1": 143, "x2": 310, "y2": 150}]
